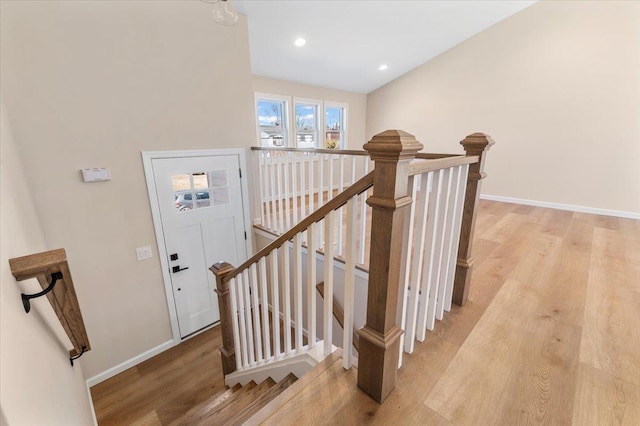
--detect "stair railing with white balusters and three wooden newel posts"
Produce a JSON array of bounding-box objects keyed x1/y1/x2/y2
[{"x1": 210, "y1": 130, "x2": 493, "y2": 402}]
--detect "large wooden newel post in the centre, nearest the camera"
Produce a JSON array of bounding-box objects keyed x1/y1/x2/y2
[{"x1": 358, "y1": 130, "x2": 422, "y2": 403}]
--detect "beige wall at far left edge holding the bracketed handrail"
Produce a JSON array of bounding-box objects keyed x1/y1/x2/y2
[{"x1": 0, "y1": 100, "x2": 93, "y2": 426}]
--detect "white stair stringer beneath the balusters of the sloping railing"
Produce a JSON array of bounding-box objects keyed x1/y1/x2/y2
[{"x1": 224, "y1": 340, "x2": 337, "y2": 387}]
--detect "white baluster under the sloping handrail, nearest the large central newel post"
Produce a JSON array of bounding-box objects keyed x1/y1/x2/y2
[{"x1": 342, "y1": 197, "x2": 358, "y2": 370}]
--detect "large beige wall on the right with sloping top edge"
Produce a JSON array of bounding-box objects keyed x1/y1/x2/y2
[{"x1": 367, "y1": 2, "x2": 640, "y2": 214}]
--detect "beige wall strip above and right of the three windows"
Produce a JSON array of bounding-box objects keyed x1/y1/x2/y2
[{"x1": 253, "y1": 75, "x2": 367, "y2": 149}]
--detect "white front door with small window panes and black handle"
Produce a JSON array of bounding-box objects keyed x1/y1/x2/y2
[{"x1": 152, "y1": 155, "x2": 247, "y2": 338}]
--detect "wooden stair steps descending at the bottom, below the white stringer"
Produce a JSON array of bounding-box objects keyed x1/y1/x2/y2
[{"x1": 172, "y1": 374, "x2": 298, "y2": 426}]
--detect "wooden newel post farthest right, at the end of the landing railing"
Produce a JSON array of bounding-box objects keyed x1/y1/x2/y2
[{"x1": 453, "y1": 133, "x2": 495, "y2": 306}]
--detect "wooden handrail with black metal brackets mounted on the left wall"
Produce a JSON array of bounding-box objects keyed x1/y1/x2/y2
[{"x1": 9, "y1": 249, "x2": 91, "y2": 365}]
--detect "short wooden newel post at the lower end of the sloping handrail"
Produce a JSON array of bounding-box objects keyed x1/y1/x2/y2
[{"x1": 209, "y1": 262, "x2": 236, "y2": 375}]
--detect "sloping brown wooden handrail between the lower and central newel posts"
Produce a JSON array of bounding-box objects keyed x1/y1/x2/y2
[{"x1": 223, "y1": 172, "x2": 373, "y2": 283}]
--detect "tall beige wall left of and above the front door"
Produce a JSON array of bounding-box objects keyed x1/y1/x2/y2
[{"x1": 1, "y1": 1, "x2": 254, "y2": 380}]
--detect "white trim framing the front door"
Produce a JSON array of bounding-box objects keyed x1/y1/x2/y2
[{"x1": 141, "y1": 148, "x2": 253, "y2": 345}]
